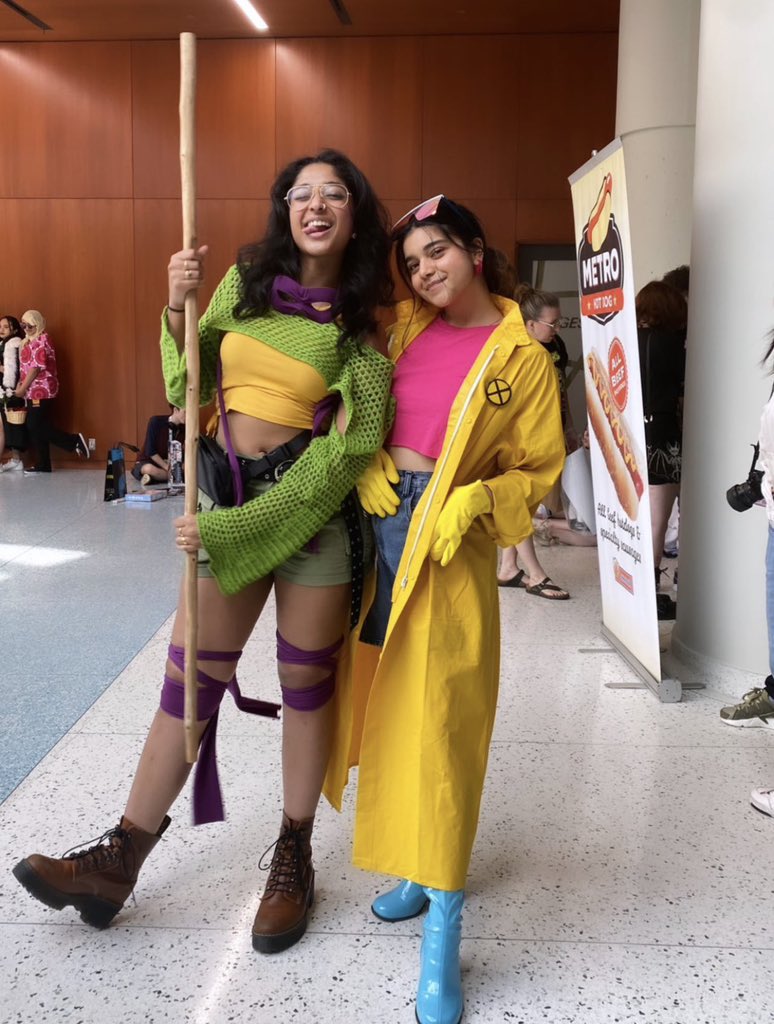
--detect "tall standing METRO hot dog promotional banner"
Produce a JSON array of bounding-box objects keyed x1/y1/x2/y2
[{"x1": 569, "y1": 139, "x2": 661, "y2": 681}]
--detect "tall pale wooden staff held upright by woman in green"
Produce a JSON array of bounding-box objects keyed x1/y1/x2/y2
[{"x1": 180, "y1": 32, "x2": 199, "y2": 764}]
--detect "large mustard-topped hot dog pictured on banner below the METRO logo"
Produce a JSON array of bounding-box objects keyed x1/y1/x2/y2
[{"x1": 586, "y1": 350, "x2": 645, "y2": 519}]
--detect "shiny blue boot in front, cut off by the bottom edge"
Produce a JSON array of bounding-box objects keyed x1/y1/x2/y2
[{"x1": 417, "y1": 889, "x2": 465, "y2": 1024}]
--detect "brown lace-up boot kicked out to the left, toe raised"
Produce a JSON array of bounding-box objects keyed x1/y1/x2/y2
[{"x1": 13, "y1": 816, "x2": 170, "y2": 928}]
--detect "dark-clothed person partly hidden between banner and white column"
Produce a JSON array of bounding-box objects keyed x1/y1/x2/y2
[{"x1": 635, "y1": 281, "x2": 688, "y2": 620}]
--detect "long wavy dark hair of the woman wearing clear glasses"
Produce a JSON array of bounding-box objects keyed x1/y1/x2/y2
[{"x1": 234, "y1": 150, "x2": 394, "y2": 345}]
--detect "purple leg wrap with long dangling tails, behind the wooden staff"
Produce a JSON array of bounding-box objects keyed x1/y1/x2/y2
[{"x1": 161, "y1": 644, "x2": 280, "y2": 825}]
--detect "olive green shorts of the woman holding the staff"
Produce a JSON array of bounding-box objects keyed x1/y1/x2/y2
[{"x1": 197, "y1": 480, "x2": 374, "y2": 587}]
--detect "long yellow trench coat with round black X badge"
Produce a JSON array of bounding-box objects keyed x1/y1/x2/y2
[{"x1": 325, "y1": 297, "x2": 564, "y2": 890}]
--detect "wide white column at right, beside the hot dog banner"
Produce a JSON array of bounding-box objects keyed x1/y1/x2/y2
[{"x1": 667, "y1": 0, "x2": 774, "y2": 696}]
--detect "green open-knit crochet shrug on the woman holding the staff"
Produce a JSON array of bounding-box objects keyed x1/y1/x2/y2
[{"x1": 161, "y1": 266, "x2": 392, "y2": 594}]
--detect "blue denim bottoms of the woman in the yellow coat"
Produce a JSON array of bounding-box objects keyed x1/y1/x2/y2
[{"x1": 360, "y1": 470, "x2": 432, "y2": 647}]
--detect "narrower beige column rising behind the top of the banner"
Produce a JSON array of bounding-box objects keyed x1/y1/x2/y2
[{"x1": 615, "y1": 0, "x2": 699, "y2": 291}]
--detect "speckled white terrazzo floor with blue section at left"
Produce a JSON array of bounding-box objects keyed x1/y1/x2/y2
[{"x1": 0, "y1": 470, "x2": 774, "y2": 1024}]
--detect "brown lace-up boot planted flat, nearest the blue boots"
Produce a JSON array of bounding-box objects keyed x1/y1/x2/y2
[{"x1": 253, "y1": 814, "x2": 314, "y2": 953}]
